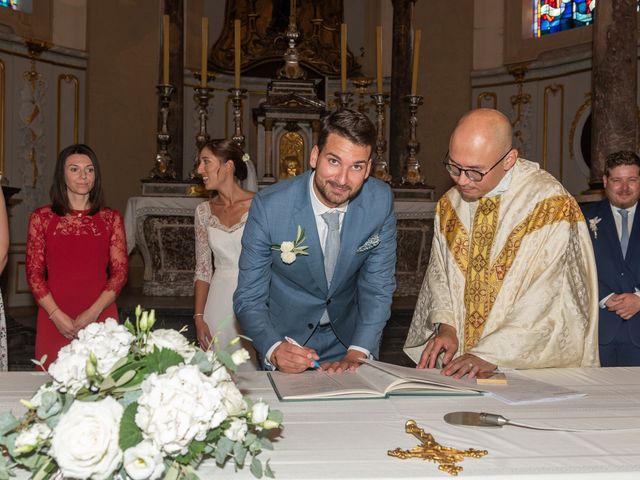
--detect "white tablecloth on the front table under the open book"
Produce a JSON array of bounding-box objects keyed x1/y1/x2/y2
[{"x1": 0, "y1": 368, "x2": 640, "y2": 480}]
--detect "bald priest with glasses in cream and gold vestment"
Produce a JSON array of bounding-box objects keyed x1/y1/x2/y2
[{"x1": 405, "y1": 109, "x2": 599, "y2": 378}]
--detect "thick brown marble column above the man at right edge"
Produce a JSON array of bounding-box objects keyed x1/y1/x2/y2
[{"x1": 589, "y1": 0, "x2": 638, "y2": 191}]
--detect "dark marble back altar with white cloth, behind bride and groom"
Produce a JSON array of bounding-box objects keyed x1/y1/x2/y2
[{"x1": 124, "y1": 196, "x2": 435, "y2": 297}]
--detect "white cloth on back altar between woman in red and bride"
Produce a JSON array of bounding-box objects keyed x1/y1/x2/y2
[{"x1": 124, "y1": 197, "x2": 206, "y2": 253}]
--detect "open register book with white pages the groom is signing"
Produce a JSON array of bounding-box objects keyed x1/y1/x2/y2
[{"x1": 268, "y1": 360, "x2": 482, "y2": 400}]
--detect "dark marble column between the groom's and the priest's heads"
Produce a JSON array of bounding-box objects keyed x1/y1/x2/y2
[{"x1": 389, "y1": 0, "x2": 416, "y2": 183}]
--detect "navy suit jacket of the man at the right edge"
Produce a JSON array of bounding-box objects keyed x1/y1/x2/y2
[{"x1": 581, "y1": 200, "x2": 640, "y2": 346}]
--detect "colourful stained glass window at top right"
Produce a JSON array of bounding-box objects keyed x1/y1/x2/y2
[{"x1": 533, "y1": 0, "x2": 596, "y2": 37}]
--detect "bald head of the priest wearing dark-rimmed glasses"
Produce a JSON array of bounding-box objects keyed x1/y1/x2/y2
[{"x1": 444, "y1": 108, "x2": 518, "y2": 201}]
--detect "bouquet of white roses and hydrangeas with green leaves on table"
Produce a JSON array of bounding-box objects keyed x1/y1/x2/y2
[{"x1": 0, "y1": 306, "x2": 282, "y2": 480}]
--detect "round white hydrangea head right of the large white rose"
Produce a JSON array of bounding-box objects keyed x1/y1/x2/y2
[{"x1": 135, "y1": 365, "x2": 228, "y2": 455}]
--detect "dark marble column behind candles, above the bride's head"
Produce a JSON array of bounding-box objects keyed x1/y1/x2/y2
[{"x1": 158, "y1": 0, "x2": 184, "y2": 180}]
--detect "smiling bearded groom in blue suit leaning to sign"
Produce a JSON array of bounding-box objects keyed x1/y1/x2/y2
[{"x1": 233, "y1": 110, "x2": 396, "y2": 373}]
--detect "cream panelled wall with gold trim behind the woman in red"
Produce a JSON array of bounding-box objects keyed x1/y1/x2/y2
[{"x1": 0, "y1": 33, "x2": 87, "y2": 307}]
